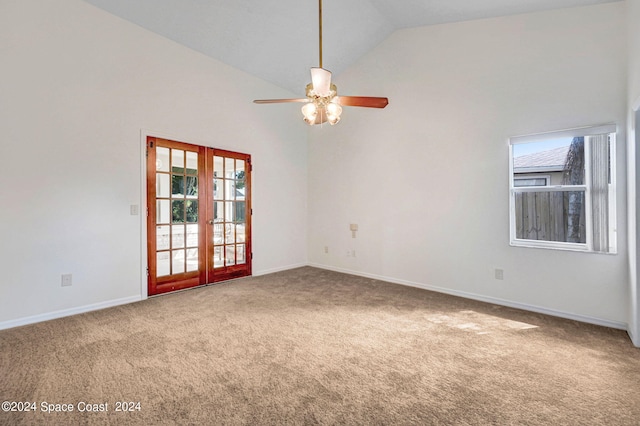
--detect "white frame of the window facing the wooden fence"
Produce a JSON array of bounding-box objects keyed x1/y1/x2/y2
[{"x1": 508, "y1": 124, "x2": 617, "y2": 254}]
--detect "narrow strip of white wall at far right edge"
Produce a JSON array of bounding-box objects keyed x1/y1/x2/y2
[{"x1": 626, "y1": 0, "x2": 640, "y2": 346}]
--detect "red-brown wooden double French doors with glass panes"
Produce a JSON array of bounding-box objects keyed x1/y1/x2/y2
[{"x1": 147, "y1": 137, "x2": 252, "y2": 295}]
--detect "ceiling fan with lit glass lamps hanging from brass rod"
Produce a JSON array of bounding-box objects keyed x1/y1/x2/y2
[{"x1": 253, "y1": 0, "x2": 389, "y2": 125}]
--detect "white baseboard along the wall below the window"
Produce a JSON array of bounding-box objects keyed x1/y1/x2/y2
[{"x1": 308, "y1": 263, "x2": 637, "y2": 332}]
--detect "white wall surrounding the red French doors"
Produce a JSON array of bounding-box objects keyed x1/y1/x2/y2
[{"x1": 0, "y1": 0, "x2": 307, "y2": 328}]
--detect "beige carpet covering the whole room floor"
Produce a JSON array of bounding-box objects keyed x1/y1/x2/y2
[{"x1": 0, "y1": 267, "x2": 640, "y2": 425}]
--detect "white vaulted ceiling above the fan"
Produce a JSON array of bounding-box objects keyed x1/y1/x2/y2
[{"x1": 85, "y1": 0, "x2": 618, "y2": 95}]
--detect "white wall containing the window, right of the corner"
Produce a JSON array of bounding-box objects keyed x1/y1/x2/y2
[{"x1": 308, "y1": 2, "x2": 629, "y2": 328}]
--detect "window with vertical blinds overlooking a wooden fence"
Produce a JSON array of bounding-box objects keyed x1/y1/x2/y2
[{"x1": 509, "y1": 124, "x2": 616, "y2": 253}]
